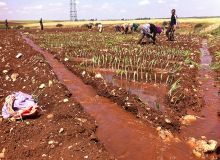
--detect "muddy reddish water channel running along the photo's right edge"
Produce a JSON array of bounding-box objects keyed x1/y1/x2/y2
[{"x1": 182, "y1": 40, "x2": 220, "y2": 143}]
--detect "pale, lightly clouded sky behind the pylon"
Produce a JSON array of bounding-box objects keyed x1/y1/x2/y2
[{"x1": 0, "y1": 0, "x2": 220, "y2": 20}]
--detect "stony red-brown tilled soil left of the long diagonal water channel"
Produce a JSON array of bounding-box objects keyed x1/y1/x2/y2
[{"x1": 0, "y1": 31, "x2": 113, "y2": 159}]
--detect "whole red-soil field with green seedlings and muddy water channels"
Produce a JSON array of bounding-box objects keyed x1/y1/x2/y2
[{"x1": 0, "y1": 19, "x2": 220, "y2": 160}]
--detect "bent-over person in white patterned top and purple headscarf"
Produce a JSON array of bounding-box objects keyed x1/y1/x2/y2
[{"x1": 138, "y1": 24, "x2": 163, "y2": 44}]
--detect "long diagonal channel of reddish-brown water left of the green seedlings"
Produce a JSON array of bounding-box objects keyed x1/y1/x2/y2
[{"x1": 22, "y1": 35, "x2": 219, "y2": 160}]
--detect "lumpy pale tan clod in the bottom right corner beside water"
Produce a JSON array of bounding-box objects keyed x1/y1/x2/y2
[{"x1": 188, "y1": 137, "x2": 218, "y2": 158}]
